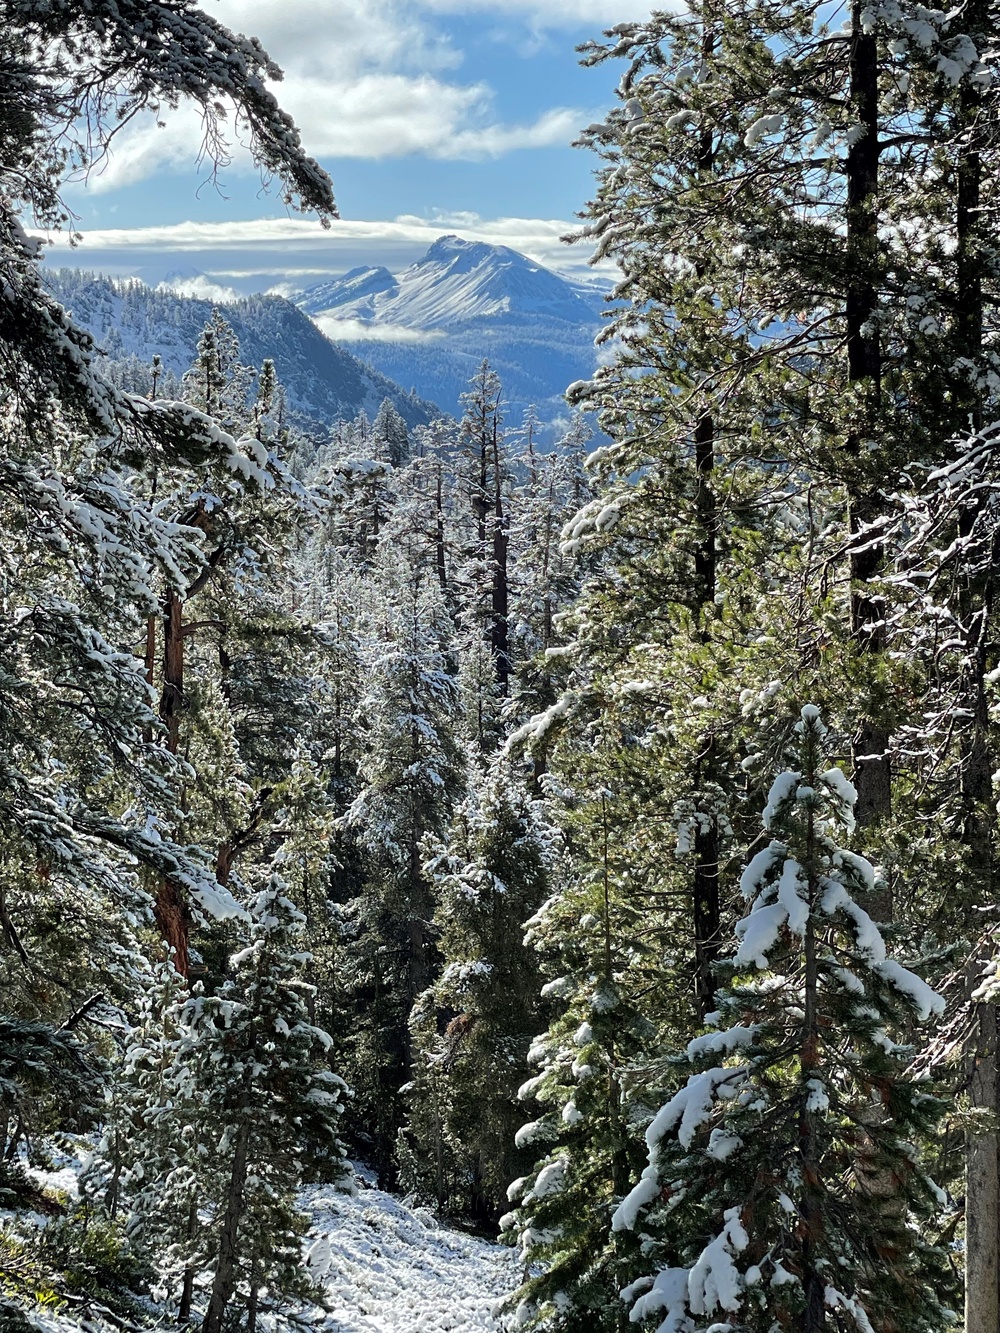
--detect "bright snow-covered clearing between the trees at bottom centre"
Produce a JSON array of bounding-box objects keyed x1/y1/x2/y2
[{"x1": 303, "y1": 1181, "x2": 520, "y2": 1333}]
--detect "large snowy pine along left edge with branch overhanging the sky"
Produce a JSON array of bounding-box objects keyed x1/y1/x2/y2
[{"x1": 0, "y1": 0, "x2": 333, "y2": 1215}]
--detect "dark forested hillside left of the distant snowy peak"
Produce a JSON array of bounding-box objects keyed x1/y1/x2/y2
[{"x1": 45, "y1": 269, "x2": 441, "y2": 427}]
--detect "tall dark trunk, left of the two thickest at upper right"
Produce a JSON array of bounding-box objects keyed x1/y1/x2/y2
[{"x1": 845, "y1": 0, "x2": 892, "y2": 831}]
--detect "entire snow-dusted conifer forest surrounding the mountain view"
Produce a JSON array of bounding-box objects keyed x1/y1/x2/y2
[{"x1": 9, "y1": 0, "x2": 1000, "y2": 1333}]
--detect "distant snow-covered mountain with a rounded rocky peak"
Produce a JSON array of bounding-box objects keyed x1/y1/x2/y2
[{"x1": 297, "y1": 236, "x2": 601, "y2": 424}]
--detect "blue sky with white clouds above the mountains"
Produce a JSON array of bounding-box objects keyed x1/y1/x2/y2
[{"x1": 51, "y1": 0, "x2": 648, "y2": 291}]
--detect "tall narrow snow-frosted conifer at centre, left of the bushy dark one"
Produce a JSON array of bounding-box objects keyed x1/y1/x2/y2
[{"x1": 341, "y1": 545, "x2": 463, "y2": 1180}]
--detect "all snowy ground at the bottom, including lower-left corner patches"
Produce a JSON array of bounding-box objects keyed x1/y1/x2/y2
[{"x1": 7, "y1": 1157, "x2": 520, "y2": 1333}]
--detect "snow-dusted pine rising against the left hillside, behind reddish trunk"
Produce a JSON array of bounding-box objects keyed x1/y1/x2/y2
[{"x1": 147, "y1": 333, "x2": 320, "y2": 972}]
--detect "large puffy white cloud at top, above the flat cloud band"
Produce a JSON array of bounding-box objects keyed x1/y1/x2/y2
[{"x1": 66, "y1": 0, "x2": 616, "y2": 193}]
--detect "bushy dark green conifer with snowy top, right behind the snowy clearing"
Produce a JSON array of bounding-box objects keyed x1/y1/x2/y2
[{"x1": 404, "y1": 758, "x2": 557, "y2": 1222}]
